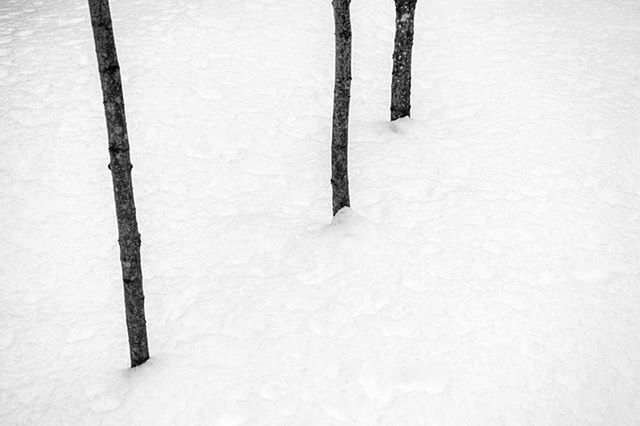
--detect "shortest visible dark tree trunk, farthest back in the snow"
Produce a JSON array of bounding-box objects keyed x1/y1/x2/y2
[{"x1": 391, "y1": 0, "x2": 417, "y2": 121}]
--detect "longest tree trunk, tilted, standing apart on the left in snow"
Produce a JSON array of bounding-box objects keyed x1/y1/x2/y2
[{"x1": 89, "y1": 0, "x2": 149, "y2": 367}]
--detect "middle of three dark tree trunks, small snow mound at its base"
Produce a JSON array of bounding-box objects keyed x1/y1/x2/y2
[{"x1": 331, "y1": 0, "x2": 351, "y2": 215}]
